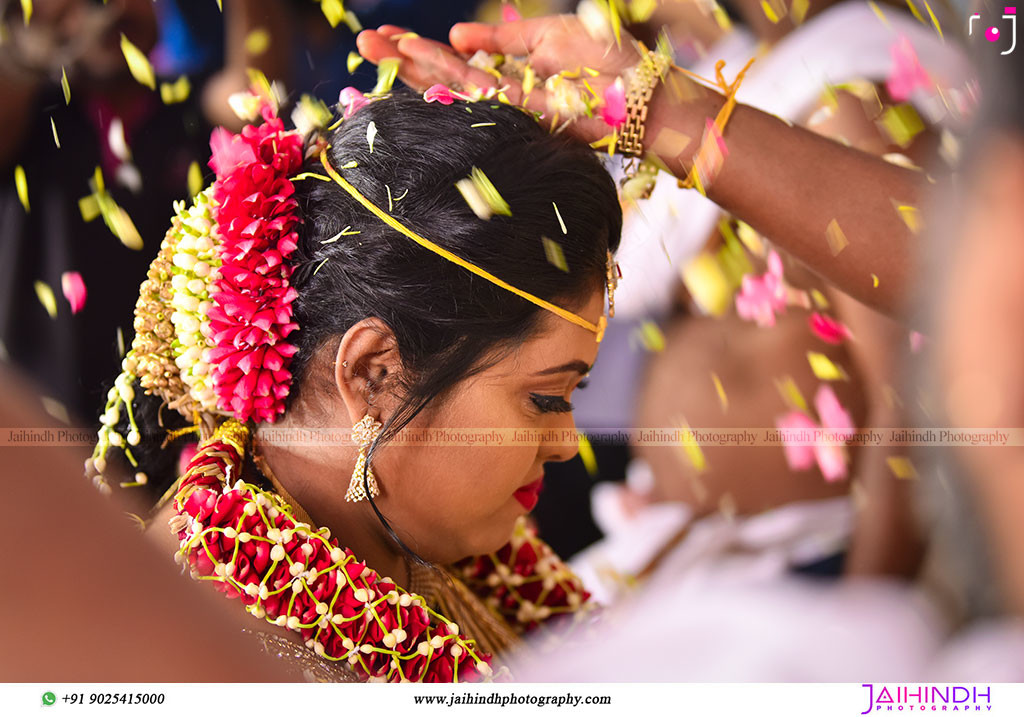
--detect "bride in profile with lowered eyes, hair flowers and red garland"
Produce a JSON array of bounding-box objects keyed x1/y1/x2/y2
[{"x1": 86, "y1": 89, "x2": 622, "y2": 681}]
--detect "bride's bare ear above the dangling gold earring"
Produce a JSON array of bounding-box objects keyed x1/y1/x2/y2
[{"x1": 334, "y1": 317, "x2": 401, "y2": 425}]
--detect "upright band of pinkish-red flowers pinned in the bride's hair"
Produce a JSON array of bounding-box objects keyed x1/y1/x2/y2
[{"x1": 205, "y1": 109, "x2": 302, "y2": 422}]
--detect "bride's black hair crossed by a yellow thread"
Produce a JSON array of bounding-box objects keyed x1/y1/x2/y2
[{"x1": 103, "y1": 93, "x2": 622, "y2": 524}]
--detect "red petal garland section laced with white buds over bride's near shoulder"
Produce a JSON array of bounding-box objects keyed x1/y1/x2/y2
[{"x1": 171, "y1": 421, "x2": 492, "y2": 682}]
